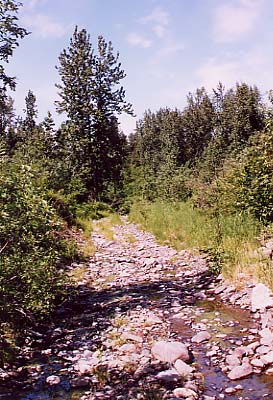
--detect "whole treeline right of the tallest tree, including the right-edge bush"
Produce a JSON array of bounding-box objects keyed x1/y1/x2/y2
[{"x1": 129, "y1": 83, "x2": 273, "y2": 222}]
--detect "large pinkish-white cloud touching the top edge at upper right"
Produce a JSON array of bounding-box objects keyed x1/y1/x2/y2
[{"x1": 213, "y1": 0, "x2": 264, "y2": 42}]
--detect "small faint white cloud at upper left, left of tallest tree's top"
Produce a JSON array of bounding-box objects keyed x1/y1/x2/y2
[{"x1": 22, "y1": 14, "x2": 70, "y2": 39}]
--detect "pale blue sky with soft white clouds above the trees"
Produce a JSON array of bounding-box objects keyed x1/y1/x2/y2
[{"x1": 4, "y1": 0, "x2": 273, "y2": 134}]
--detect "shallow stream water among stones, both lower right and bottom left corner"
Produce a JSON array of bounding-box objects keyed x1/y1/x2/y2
[{"x1": 4, "y1": 295, "x2": 273, "y2": 400}]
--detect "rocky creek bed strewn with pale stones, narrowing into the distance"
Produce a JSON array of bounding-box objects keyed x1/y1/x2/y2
[{"x1": 0, "y1": 220, "x2": 273, "y2": 400}]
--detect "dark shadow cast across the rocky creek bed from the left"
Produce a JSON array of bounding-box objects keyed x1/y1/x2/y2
[{"x1": 0, "y1": 272, "x2": 214, "y2": 400}]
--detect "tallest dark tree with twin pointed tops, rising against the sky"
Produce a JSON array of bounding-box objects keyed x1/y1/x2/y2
[{"x1": 56, "y1": 27, "x2": 132, "y2": 199}]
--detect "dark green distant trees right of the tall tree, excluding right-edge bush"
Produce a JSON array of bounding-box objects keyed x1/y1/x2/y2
[{"x1": 129, "y1": 83, "x2": 265, "y2": 205}]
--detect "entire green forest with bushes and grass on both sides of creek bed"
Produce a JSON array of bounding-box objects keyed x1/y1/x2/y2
[{"x1": 0, "y1": 0, "x2": 273, "y2": 365}]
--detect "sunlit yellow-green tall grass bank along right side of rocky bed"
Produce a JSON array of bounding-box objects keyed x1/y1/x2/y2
[{"x1": 130, "y1": 202, "x2": 273, "y2": 286}]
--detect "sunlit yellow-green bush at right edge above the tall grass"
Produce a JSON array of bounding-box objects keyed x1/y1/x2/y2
[{"x1": 216, "y1": 131, "x2": 273, "y2": 223}]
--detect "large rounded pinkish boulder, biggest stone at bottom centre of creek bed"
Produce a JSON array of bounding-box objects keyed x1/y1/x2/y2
[{"x1": 151, "y1": 340, "x2": 190, "y2": 363}]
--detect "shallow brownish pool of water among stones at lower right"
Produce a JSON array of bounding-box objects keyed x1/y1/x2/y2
[{"x1": 172, "y1": 301, "x2": 273, "y2": 400}]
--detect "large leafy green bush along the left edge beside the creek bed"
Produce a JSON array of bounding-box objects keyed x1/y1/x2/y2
[{"x1": 0, "y1": 159, "x2": 75, "y2": 324}]
